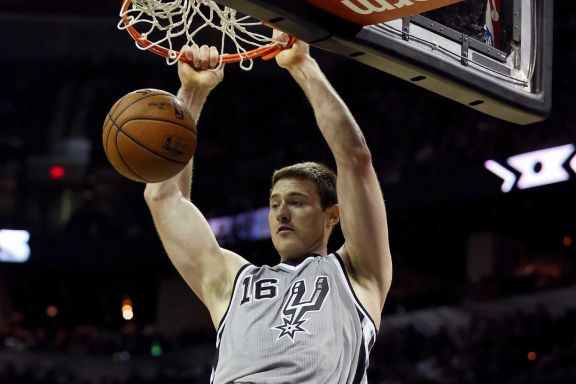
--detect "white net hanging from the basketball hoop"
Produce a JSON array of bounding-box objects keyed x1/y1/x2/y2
[{"x1": 118, "y1": 0, "x2": 273, "y2": 70}]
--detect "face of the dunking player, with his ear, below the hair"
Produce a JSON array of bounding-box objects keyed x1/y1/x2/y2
[{"x1": 268, "y1": 178, "x2": 338, "y2": 260}]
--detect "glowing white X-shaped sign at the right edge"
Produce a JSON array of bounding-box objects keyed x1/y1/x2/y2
[{"x1": 484, "y1": 144, "x2": 576, "y2": 193}]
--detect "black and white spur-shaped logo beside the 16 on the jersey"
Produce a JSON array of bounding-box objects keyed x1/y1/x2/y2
[{"x1": 272, "y1": 276, "x2": 330, "y2": 342}]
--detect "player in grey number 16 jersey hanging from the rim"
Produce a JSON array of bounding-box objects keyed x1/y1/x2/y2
[{"x1": 145, "y1": 35, "x2": 392, "y2": 384}]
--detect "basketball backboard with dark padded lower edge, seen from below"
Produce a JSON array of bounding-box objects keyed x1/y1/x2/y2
[{"x1": 216, "y1": 0, "x2": 553, "y2": 124}]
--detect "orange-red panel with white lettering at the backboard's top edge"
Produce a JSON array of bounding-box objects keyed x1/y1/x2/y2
[{"x1": 308, "y1": 0, "x2": 462, "y2": 25}]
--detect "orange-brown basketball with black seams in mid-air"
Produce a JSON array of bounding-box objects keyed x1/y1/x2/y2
[{"x1": 102, "y1": 89, "x2": 196, "y2": 183}]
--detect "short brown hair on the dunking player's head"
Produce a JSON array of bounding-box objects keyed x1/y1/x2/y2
[{"x1": 270, "y1": 161, "x2": 338, "y2": 209}]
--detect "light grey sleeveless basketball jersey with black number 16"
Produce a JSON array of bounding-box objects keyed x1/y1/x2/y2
[{"x1": 211, "y1": 253, "x2": 376, "y2": 384}]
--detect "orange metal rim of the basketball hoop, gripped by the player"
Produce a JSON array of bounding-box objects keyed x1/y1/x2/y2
[{"x1": 121, "y1": 0, "x2": 297, "y2": 63}]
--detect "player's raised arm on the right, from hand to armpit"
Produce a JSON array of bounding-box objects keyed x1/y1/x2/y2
[{"x1": 277, "y1": 36, "x2": 392, "y2": 320}]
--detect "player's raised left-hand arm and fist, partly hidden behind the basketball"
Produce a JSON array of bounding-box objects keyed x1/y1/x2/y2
[{"x1": 144, "y1": 46, "x2": 247, "y2": 327}]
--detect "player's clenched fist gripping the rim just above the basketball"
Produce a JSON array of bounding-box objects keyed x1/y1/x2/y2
[{"x1": 178, "y1": 45, "x2": 224, "y2": 91}]
